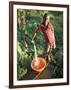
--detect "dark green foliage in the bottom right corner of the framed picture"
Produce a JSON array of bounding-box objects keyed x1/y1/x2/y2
[{"x1": 51, "y1": 52, "x2": 63, "y2": 78}]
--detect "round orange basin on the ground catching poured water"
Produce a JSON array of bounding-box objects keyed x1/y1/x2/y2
[{"x1": 31, "y1": 57, "x2": 46, "y2": 73}]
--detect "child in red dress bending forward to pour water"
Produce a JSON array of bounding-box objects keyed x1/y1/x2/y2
[{"x1": 32, "y1": 13, "x2": 56, "y2": 61}]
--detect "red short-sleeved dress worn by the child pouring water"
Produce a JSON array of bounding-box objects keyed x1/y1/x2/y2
[{"x1": 36, "y1": 23, "x2": 55, "y2": 46}]
